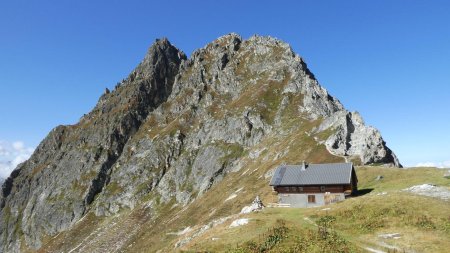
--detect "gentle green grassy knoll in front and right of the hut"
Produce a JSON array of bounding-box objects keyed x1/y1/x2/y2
[{"x1": 176, "y1": 167, "x2": 450, "y2": 252}]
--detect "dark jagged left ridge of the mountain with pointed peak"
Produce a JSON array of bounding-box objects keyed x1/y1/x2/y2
[{"x1": 0, "y1": 39, "x2": 185, "y2": 252}]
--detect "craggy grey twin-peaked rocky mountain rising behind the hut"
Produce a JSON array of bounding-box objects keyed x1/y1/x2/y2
[{"x1": 0, "y1": 34, "x2": 401, "y2": 252}]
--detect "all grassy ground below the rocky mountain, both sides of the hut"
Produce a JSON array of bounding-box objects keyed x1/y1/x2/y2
[{"x1": 40, "y1": 166, "x2": 450, "y2": 252}]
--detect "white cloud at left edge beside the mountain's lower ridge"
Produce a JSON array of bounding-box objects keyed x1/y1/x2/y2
[{"x1": 0, "y1": 140, "x2": 34, "y2": 178}]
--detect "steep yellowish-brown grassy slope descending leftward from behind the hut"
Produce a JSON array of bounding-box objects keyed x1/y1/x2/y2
[{"x1": 35, "y1": 121, "x2": 343, "y2": 253}]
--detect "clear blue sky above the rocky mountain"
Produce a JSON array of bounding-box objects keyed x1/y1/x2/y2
[{"x1": 0, "y1": 0, "x2": 450, "y2": 176}]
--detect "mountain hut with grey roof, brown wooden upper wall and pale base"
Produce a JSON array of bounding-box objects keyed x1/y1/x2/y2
[{"x1": 270, "y1": 162, "x2": 358, "y2": 207}]
